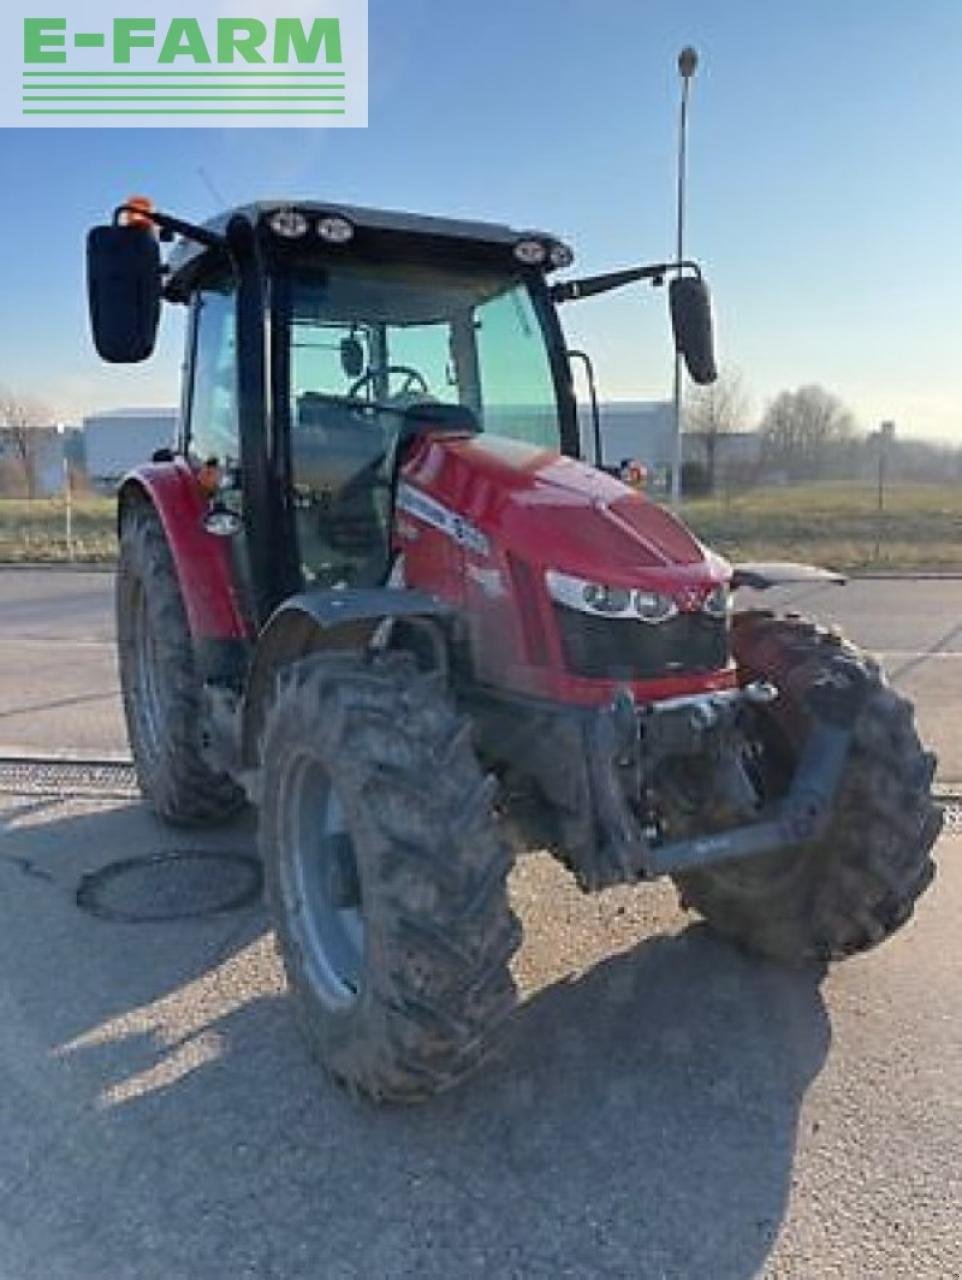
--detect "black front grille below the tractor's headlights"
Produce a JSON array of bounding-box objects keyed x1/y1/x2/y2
[{"x1": 554, "y1": 604, "x2": 729, "y2": 680}]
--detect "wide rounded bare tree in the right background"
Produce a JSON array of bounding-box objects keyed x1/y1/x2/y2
[{"x1": 760, "y1": 385, "x2": 856, "y2": 480}]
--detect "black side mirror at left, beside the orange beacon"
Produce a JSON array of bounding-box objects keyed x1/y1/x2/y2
[{"x1": 87, "y1": 227, "x2": 161, "y2": 365}]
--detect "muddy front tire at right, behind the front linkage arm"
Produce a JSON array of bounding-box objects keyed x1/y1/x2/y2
[{"x1": 675, "y1": 613, "x2": 942, "y2": 964}]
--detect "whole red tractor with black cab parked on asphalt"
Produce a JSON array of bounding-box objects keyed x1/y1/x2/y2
[{"x1": 87, "y1": 200, "x2": 942, "y2": 1101}]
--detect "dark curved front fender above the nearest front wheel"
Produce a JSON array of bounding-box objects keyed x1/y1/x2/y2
[{"x1": 242, "y1": 588, "x2": 452, "y2": 768}]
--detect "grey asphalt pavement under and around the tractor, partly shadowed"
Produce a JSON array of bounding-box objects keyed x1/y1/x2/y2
[{"x1": 0, "y1": 572, "x2": 962, "y2": 1280}]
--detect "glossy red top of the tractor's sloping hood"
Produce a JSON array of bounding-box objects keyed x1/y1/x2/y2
[{"x1": 404, "y1": 434, "x2": 732, "y2": 588}]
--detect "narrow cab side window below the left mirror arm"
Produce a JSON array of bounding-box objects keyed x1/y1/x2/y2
[{"x1": 187, "y1": 280, "x2": 241, "y2": 467}]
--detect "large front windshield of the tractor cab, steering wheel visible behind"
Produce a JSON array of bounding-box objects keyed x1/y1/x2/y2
[{"x1": 281, "y1": 264, "x2": 562, "y2": 585}]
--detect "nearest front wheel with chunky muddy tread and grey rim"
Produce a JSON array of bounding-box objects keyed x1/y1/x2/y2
[{"x1": 260, "y1": 654, "x2": 521, "y2": 1102}]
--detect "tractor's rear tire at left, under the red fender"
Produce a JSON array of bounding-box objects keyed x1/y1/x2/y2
[{"x1": 116, "y1": 502, "x2": 244, "y2": 826}]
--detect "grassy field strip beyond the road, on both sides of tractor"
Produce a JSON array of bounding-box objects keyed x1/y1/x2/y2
[{"x1": 0, "y1": 484, "x2": 962, "y2": 571}]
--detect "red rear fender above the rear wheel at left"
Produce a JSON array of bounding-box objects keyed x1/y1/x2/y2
[{"x1": 118, "y1": 458, "x2": 251, "y2": 644}]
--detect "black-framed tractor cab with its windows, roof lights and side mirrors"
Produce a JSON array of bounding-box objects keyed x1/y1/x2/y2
[{"x1": 88, "y1": 198, "x2": 714, "y2": 623}]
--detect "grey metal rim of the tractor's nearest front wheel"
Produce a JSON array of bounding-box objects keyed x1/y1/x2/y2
[{"x1": 280, "y1": 755, "x2": 366, "y2": 1010}]
